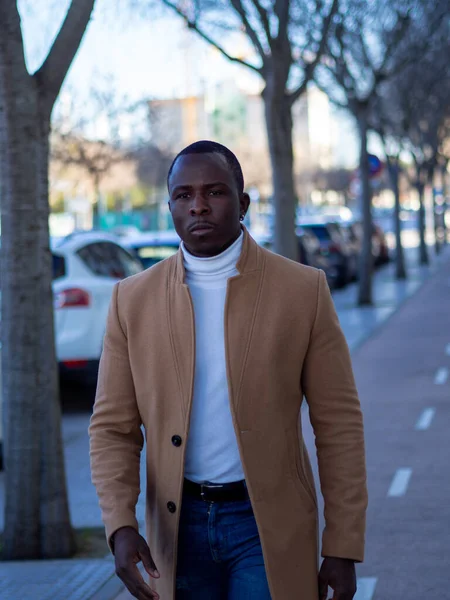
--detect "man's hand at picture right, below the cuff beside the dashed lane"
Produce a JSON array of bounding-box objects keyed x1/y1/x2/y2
[{"x1": 319, "y1": 556, "x2": 356, "y2": 600}]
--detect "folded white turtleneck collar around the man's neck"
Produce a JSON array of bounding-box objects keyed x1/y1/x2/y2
[{"x1": 181, "y1": 231, "x2": 244, "y2": 281}]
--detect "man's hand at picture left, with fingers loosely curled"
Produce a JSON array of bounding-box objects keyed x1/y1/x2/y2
[{"x1": 114, "y1": 527, "x2": 159, "y2": 600}]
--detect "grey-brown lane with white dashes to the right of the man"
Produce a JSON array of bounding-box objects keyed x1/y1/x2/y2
[{"x1": 304, "y1": 247, "x2": 450, "y2": 600}]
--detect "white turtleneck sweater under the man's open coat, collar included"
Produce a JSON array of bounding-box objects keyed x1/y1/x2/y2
[{"x1": 181, "y1": 233, "x2": 244, "y2": 483}]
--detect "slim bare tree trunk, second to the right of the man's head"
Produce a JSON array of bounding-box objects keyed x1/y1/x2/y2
[{"x1": 356, "y1": 107, "x2": 373, "y2": 306}]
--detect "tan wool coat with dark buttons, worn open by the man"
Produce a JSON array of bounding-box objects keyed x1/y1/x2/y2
[{"x1": 90, "y1": 231, "x2": 367, "y2": 600}]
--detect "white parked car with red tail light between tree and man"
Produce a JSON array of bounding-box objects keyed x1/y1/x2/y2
[{"x1": 52, "y1": 232, "x2": 143, "y2": 382}]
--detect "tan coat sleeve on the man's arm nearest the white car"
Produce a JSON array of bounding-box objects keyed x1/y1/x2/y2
[{"x1": 89, "y1": 284, "x2": 143, "y2": 549}]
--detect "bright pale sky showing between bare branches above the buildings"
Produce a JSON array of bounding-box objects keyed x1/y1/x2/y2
[{"x1": 18, "y1": 0, "x2": 362, "y2": 164}]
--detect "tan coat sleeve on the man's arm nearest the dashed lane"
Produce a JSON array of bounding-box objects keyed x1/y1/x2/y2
[{"x1": 302, "y1": 271, "x2": 367, "y2": 561}]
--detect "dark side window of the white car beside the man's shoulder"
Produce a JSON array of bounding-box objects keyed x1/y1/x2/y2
[{"x1": 77, "y1": 242, "x2": 142, "y2": 279}]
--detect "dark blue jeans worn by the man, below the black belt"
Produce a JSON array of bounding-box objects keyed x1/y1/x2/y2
[{"x1": 175, "y1": 494, "x2": 270, "y2": 600}]
